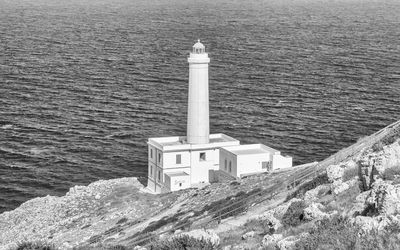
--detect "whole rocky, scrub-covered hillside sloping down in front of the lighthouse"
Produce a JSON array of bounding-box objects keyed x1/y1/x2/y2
[{"x1": 0, "y1": 122, "x2": 400, "y2": 250}]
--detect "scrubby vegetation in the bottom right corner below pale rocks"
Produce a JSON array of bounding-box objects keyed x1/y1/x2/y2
[{"x1": 296, "y1": 216, "x2": 400, "y2": 250}]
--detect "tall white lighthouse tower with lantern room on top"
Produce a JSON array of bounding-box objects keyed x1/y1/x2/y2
[{"x1": 187, "y1": 40, "x2": 210, "y2": 144}]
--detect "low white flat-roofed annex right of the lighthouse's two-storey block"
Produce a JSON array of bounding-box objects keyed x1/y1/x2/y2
[{"x1": 219, "y1": 144, "x2": 292, "y2": 178}]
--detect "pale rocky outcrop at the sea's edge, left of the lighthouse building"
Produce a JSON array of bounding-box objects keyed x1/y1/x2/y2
[{"x1": 0, "y1": 178, "x2": 153, "y2": 249}]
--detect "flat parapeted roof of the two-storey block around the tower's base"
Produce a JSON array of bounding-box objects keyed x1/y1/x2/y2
[{"x1": 147, "y1": 134, "x2": 240, "y2": 151}]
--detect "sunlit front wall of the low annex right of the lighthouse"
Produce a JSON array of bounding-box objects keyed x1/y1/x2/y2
[{"x1": 236, "y1": 153, "x2": 272, "y2": 177}]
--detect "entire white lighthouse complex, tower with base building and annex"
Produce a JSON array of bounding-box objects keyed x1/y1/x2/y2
[{"x1": 147, "y1": 41, "x2": 291, "y2": 193}]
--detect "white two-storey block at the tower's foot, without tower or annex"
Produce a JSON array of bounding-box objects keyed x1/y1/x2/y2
[{"x1": 147, "y1": 134, "x2": 240, "y2": 193}]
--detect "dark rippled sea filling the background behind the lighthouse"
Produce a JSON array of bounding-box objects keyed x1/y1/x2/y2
[{"x1": 0, "y1": 0, "x2": 400, "y2": 212}]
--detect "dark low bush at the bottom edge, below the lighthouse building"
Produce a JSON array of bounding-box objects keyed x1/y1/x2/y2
[{"x1": 147, "y1": 235, "x2": 217, "y2": 250}]
